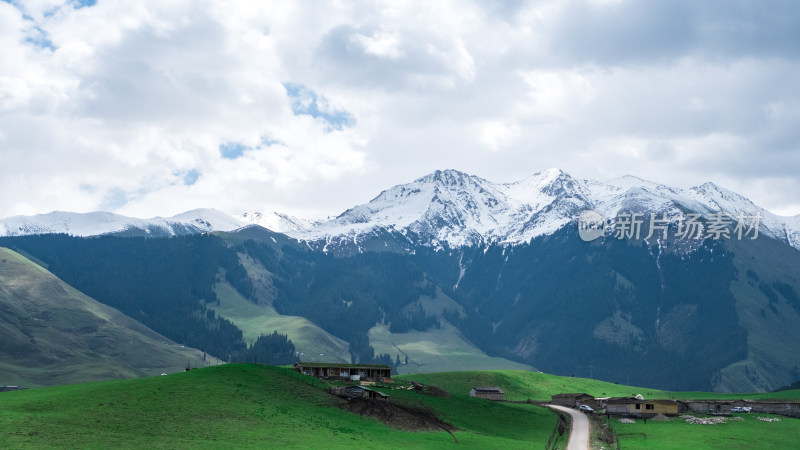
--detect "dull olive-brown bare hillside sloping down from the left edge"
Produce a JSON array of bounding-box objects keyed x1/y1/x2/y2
[{"x1": 0, "y1": 247, "x2": 216, "y2": 387}]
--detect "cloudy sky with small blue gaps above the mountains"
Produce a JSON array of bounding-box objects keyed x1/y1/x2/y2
[{"x1": 0, "y1": 0, "x2": 800, "y2": 217}]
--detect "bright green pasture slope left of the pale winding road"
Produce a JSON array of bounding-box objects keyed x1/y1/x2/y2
[{"x1": 0, "y1": 364, "x2": 557, "y2": 448}]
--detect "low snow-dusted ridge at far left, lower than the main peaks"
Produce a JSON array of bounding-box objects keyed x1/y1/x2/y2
[{"x1": 0, "y1": 209, "x2": 246, "y2": 236}]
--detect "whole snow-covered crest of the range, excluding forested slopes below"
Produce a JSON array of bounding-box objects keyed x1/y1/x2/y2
[{"x1": 0, "y1": 169, "x2": 800, "y2": 252}]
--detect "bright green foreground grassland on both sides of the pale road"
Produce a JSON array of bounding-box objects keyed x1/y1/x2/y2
[{"x1": 0, "y1": 364, "x2": 800, "y2": 449}]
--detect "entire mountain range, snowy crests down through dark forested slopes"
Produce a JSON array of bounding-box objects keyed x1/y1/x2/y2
[{"x1": 0, "y1": 169, "x2": 800, "y2": 391}]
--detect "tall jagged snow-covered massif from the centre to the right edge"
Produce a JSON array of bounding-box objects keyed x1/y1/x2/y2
[{"x1": 287, "y1": 169, "x2": 800, "y2": 249}]
